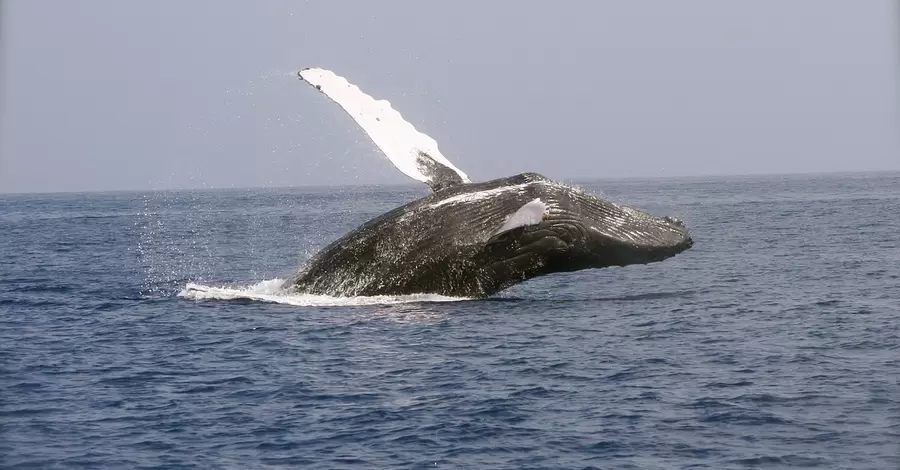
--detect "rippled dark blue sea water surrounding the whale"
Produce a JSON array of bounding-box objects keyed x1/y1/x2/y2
[{"x1": 0, "y1": 174, "x2": 900, "y2": 469}]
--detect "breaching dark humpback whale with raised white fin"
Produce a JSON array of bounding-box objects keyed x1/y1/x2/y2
[{"x1": 285, "y1": 68, "x2": 693, "y2": 298}]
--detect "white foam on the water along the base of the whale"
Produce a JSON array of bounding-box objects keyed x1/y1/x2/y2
[{"x1": 178, "y1": 279, "x2": 469, "y2": 307}]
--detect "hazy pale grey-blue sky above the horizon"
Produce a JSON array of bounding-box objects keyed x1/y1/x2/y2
[{"x1": 0, "y1": 0, "x2": 900, "y2": 193}]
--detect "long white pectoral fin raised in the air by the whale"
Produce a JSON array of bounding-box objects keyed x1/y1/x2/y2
[{"x1": 297, "y1": 68, "x2": 471, "y2": 191}]
